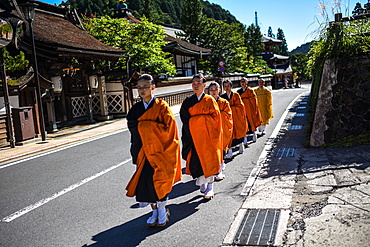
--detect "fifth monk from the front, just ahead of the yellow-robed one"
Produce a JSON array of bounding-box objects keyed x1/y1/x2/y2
[{"x1": 237, "y1": 78, "x2": 262, "y2": 147}]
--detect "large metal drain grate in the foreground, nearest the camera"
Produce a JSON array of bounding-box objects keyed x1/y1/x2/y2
[{"x1": 234, "y1": 209, "x2": 280, "y2": 246}]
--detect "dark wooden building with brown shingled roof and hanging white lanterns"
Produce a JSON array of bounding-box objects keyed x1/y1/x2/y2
[{"x1": 1, "y1": 0, "x2": 127, "y2": 138}]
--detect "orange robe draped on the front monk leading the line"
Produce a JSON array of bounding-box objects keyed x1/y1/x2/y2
[{"x1": 126, "y1": 99, "x2": 182, "y2": 199}]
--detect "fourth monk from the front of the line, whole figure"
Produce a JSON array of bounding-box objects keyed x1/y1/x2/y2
[{"x1": 221, "y1": 80, "x2": 248, "y2": 159}]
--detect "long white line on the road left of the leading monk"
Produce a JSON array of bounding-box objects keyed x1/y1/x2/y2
[{"x1": 1, "y1": 159, "x2": 131, "y2": 223}]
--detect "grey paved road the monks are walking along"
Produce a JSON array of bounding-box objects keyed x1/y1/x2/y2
[{"x1": 0, "y1": 86, "x2": 309, "y2": 246}]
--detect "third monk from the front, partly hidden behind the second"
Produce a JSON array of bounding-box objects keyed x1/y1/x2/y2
[{"x1": 208, "y1": 82, "x2": 233, "y2": 181}]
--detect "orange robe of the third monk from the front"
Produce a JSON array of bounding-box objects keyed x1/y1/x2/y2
[{"x1": 217, "y1": 97, "x2": 233, "y2": 151}]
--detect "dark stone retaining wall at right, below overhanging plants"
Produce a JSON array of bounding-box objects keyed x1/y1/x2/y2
[{"x1": 310, "y1": 57, "x2": 370, "y2": 147}]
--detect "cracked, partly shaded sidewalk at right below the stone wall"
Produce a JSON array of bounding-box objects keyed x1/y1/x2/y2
[{"x1": 223, "y1": 93, "x2": 370, "y2": 247}]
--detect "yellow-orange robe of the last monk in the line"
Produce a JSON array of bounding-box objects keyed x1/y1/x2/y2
[{"x1": 254, "y1": 87, "x2": 274, "y2": 125}]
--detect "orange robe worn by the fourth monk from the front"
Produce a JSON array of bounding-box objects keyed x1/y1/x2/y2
[{"x1": 221, "y1": 92, "x2": 248, "y2": 147}]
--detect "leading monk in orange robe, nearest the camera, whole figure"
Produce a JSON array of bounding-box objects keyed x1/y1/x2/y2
[{"x1": 126, "y1": 74, "x2": 182, "y2": 226}]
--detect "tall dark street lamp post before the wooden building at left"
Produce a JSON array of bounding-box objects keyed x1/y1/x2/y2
[{"x1": 19, "y1": 0, "x2": 46, "y2": 141}]
